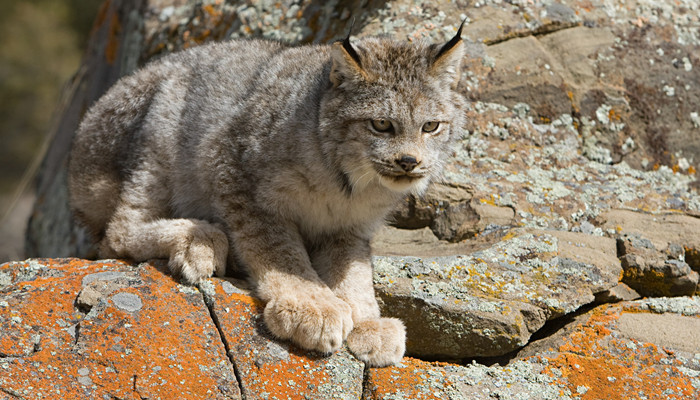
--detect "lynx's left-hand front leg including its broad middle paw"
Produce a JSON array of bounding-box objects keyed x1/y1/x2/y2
[{"x1": 227, "y1": 211, "x2": 353, "y2": 353}]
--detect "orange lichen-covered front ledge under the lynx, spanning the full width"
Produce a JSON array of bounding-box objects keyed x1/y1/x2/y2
[{"x1": 0, "y1": 259, "x2": 700, "y2": 400}]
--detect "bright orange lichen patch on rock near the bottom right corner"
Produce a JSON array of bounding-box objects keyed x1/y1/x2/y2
[{"x1": 543, "y1": 306, "x2": 696, "y2": 400}]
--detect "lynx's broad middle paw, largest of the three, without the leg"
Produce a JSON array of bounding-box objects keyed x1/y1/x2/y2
[{"x1": 264, "y1": 290, "x2": 352, "y2": 353}]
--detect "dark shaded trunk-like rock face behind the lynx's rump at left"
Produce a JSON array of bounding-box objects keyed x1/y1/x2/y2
[{"x1": 25, "y1": 0, "x2": 144, "y2": 257}]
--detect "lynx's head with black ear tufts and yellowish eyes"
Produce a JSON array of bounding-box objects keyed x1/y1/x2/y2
[{"x1": 320, "y1": 23, "x2": 464, "y2": 193}]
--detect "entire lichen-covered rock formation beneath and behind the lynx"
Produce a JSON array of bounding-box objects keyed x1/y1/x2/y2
[{"x1": 15, "y1": 0, "x2": 700, "y2": 399}]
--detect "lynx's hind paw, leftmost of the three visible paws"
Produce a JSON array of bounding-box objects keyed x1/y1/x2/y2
[{"x1": 168, "y1": 222, "x2": 228, "y2": 284}]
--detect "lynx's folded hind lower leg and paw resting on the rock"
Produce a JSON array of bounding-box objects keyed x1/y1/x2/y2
[{"x1": 100, "y1": 208, "x2": 228, "y2": 284}]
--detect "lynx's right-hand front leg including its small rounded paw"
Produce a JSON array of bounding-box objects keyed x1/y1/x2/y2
[{"x1": 313, "y1": 234, "x2": 406, "y2": 367}]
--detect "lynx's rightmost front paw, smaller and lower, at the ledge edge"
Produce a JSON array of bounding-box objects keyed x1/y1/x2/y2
[{"x1": 348, "y1": 318, "x2": 406, "y2": 367}]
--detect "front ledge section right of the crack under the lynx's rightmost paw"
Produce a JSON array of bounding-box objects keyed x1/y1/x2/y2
[{"x1": 364, "y1": 297, "x2": 700, "y2": 400}]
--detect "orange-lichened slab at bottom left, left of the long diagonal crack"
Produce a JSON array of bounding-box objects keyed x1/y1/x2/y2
[{"x1": 0, "y1": 259, "x2": 241, "y2": 399}]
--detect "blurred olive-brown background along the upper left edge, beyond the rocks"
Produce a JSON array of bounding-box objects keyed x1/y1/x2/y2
[{"x1": 0, "y1": 0, "x2": 102, "y2": 262}]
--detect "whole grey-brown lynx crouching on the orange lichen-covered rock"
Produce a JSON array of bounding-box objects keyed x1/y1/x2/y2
[{"x1": 69, "y1": 27, "x2": 464, "y2": 366}]
